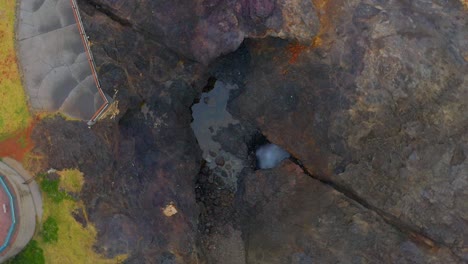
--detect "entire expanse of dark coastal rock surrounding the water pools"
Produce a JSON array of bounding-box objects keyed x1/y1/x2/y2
[{"x1": 29, "y1": 0, "x2": 468, "y2": 263}]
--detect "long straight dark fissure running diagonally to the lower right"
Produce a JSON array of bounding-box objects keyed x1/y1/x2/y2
[{"x1": 290, "y1": 156, "x2": 456, "y2": 256}]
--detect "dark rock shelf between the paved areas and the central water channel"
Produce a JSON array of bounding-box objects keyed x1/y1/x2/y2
[{"x1": 34, "y1": 1, "x2": 207, "y2": 263}]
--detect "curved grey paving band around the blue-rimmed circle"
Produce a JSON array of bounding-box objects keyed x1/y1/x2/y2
[{"x1": 0, "y1": 158, "x2": 43, "y2": 263}]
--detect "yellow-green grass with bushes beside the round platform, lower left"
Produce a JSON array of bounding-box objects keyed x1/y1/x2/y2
[{"x1": 31, "y1": 170, "x2": 127, "y2": 264}]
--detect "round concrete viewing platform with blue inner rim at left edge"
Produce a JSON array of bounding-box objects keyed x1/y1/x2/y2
[{"x1": 0, "y1": 158, "x2": 43, "y2": 263}]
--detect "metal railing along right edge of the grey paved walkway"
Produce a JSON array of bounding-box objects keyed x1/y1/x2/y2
[{"x1": 70, "y1": 0, "x2": 110, "y2": 124}]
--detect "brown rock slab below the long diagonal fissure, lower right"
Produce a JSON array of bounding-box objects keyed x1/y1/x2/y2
[{"x1": 240, "y1": 162, "x2": 457, "y2": 264}]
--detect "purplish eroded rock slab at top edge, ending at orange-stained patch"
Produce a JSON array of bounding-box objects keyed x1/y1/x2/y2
[{"x1": 85, "y1": 0, "x2": 319, "y2": 64}]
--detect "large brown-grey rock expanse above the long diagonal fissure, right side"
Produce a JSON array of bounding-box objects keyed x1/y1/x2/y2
[{"x1": 230, "y1": 1, "x2": 468, "y2": 262}]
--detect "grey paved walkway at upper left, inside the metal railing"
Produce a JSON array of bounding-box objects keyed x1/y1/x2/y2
[{"x1": 17, "y1": 0, "x2": 104, "y2": 120}]
